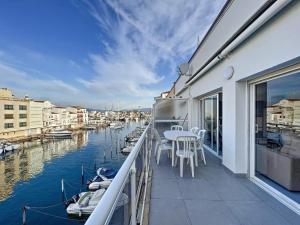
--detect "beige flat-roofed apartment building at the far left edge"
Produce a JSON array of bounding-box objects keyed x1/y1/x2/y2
[{"x1": 0, "y1": 88, "x2": 29, "y2": 139}]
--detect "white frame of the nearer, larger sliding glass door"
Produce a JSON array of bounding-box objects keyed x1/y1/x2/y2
[{"x1": 247, "y1": 68, "x2": 300, "y2": 215}]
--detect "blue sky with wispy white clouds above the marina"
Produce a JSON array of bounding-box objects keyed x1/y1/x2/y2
[{"x1": 0, "y1": 0, "x2": 225, "y2": 109}]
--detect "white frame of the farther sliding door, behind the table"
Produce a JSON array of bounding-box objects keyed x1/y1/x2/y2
[{"x1": 199, "y1": 91, "x2": 223, "y2": 159}]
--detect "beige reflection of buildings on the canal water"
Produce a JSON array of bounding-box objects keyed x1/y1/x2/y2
[{"x1": 0, "y1": 132, "x2": 88, "y2": 201}]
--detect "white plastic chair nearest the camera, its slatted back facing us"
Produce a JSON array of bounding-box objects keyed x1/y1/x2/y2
[{"x1": 175, "y1": 136, "x2": 197, "y2": 178}]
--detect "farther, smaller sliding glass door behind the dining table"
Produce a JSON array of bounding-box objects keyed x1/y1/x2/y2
[{"x1": 202, "y1": 93, "x2": 222, "y2": 156}]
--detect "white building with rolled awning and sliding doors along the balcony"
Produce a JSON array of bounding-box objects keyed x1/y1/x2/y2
[{"x1": 154, "y1": 0, "x2": 300, "y2": 216}]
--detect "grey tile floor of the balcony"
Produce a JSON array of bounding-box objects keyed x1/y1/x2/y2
[{"x1": 149, "y1": 152, "x2": 300, "y2": 225}]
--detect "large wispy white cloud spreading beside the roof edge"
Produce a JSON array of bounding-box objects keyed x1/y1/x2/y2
[{"x1": 78, "y1": 0, "x2": 225, "y2": 102}]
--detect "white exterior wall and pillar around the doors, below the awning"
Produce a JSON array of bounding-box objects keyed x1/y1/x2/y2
[{"x1": 176, "y1": 2, "x2": 300, "y2": 173}]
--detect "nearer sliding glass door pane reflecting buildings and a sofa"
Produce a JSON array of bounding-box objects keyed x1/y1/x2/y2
[{"x1": 254, "y1": 72, "x2": 300, "y2": 204}]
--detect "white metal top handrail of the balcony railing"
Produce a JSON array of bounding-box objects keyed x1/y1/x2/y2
[{"x1": 85, "y1": 123, "x2": 151, "y2": 225}]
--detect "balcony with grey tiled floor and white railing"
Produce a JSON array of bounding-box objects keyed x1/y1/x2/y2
[{"x1": 82, "y1": 124, "x2": 300, "y2": 225}]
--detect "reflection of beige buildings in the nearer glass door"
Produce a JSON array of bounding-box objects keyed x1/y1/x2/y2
[{"x1": 267, "y1": 99, "x2": 300, "y2": 126}]
